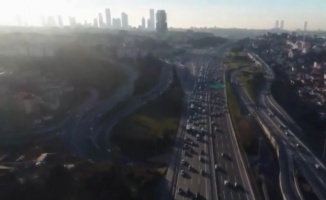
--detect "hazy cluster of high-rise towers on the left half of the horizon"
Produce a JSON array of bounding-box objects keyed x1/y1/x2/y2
[{"x1": 37, "y1": 8, "x2": 168, "y2": 33}]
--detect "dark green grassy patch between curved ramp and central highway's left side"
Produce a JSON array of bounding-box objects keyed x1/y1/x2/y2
[{"x1": 111, "y1": 69, "x2": 183, "y2": 160}]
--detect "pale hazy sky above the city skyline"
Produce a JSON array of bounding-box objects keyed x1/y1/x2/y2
[{"x1": 0, "y1": 0, "x2": 326, "y2": 30}]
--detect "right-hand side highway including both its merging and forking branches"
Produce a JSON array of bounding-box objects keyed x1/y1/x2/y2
[{"x1": 233, "y1": 51, "x2": 326, "y2": 199}]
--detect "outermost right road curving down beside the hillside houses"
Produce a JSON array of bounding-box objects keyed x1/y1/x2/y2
[{"x1": 255, "y1": 52, "x2": 326, "y2": 199}]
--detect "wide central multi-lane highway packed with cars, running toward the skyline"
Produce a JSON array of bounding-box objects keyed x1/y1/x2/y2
[{"x1": 172, "y1": 43, "x2": 255, "y2": 200}]
